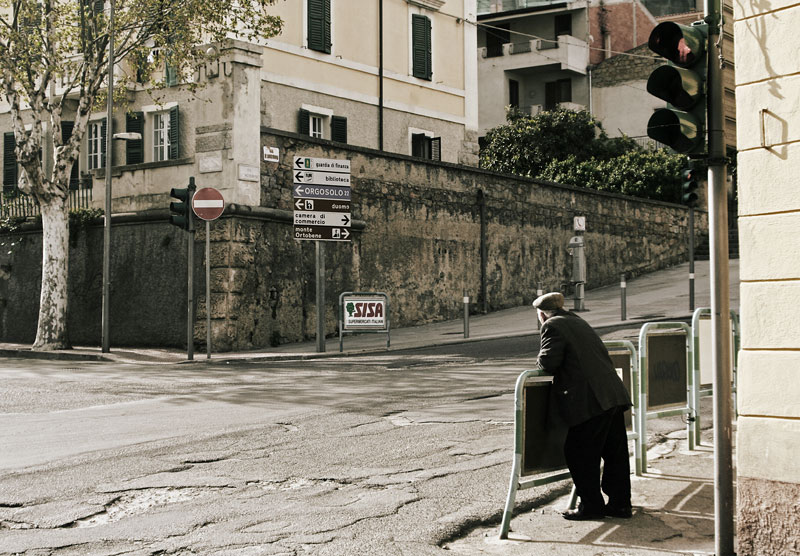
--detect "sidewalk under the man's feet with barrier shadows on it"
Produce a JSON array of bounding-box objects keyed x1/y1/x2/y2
[{"x1": 446, "y1": 424, "x2": 714, "y2": 556}]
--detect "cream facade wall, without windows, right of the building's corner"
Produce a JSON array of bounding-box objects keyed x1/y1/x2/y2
[{"x1": 261, "y1": 0, "x2": 478, "y2": 164}]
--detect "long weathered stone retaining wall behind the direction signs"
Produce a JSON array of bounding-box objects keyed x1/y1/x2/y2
[{"x1": 0, "y1": 129, "x2": 707, "y2": 351}]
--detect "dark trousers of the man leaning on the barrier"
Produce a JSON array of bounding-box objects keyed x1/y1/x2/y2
[{"x1": 564, "y1": 407, "x2": 631, "y2": 512}]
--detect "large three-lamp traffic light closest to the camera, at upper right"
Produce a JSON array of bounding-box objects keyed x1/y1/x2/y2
[{"x1": 647, "y1": 21, "x2": 708, "y2": 154}]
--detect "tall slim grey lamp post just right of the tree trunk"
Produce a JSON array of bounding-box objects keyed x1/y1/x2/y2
[{"x1": 100, "y1": 0, "x2": 114, "y2": 353}]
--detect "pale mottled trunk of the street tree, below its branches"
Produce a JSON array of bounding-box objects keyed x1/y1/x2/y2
[{"x1": 33, "y1": 195, "x2": 70, "y2": 350}]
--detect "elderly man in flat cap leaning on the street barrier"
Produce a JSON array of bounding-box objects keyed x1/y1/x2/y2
[{"x1": 533, "y1": 293, "x2": 632, "y2": 520}]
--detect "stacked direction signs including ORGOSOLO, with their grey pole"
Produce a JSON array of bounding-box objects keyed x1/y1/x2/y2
[{"x1": 292, "y1": 156, "x2": 352, "y2": 353}]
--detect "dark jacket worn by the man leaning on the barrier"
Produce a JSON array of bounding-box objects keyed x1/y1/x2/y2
[{"x1": 538, "y1": 309, "x2": 632, "y2": 427}]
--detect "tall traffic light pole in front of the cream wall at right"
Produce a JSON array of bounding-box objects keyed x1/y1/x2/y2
[{"x1": 704, "y1": 0, "x2": 734, "y2": 556}]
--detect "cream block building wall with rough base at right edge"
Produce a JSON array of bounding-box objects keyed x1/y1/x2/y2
[{"x1": 734, "y1": 0, "x2": 800, "y2": 556}]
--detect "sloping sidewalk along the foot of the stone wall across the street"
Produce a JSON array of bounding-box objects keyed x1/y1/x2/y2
[{"x1": 0, "y1": 260, "x2": 739, "y2": 364}]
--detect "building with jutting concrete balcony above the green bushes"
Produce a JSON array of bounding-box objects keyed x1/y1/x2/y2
[{"x1": 478, "y1": 0, "x2": 656, "y2": 135}]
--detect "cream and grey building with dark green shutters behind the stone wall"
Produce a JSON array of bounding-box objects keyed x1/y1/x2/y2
[{"x1": 0, "y1": 0, "x2": 478, "y2": 212}]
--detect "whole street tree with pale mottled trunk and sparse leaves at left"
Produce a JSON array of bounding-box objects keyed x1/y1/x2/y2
[{"x1": 0, "y1": 0, "x2": 282, "y2": 350}]
